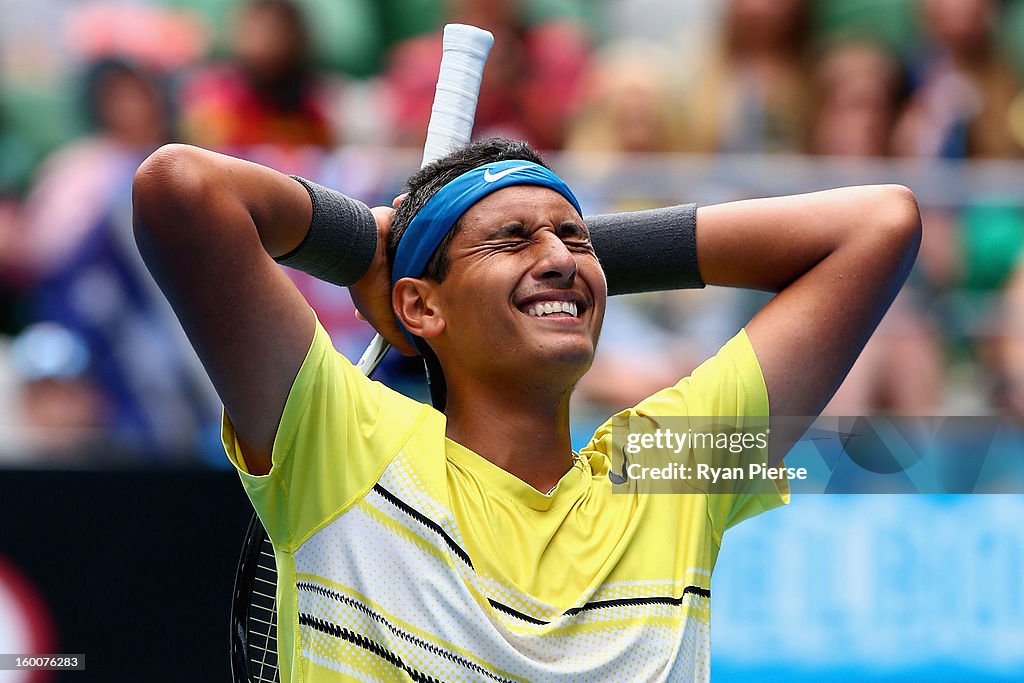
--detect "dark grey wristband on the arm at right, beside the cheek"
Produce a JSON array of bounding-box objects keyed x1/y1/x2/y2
[{"x1": 587, "y1": 204, "x2": 705, "y2": 295}]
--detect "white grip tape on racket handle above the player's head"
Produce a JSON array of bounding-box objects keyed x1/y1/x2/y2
[{"x1": 421, "y1": 24, "x2": 495, "y2": 166}]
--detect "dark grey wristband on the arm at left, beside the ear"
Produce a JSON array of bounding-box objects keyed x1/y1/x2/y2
[{"x1": 274, "y1": 175, "x2": 377, "y2": 287}]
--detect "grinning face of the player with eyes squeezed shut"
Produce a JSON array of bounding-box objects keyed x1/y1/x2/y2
[{"x1": 428, "y1": 185, "x2": 607, "y2": 384}]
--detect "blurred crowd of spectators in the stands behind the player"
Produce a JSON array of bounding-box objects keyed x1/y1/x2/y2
[{"x1": 0, "y1": 0, "x2": 1024, "y2": 463}]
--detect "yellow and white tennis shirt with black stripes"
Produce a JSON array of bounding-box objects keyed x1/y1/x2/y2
[{"x1": 223, "y1": 323, "x2": 788, "y2": 683}]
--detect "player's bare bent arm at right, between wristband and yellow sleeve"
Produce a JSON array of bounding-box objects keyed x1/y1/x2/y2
[{"x1": 697, "y1": 185, "x2": 921, "y2": 430}]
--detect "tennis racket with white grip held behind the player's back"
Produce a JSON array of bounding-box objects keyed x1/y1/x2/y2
[{"x1": 230, "y1": 24, "x2": 495, "y2": 683}]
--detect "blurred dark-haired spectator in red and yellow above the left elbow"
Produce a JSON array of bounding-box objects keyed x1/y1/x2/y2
[{"x1": 181, "y1": 0, "x2": 340, "y2": 150}]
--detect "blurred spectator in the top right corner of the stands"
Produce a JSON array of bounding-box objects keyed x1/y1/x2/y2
[{"x1": 896, "y1": 0, "x2": 1021, "y2": 159}]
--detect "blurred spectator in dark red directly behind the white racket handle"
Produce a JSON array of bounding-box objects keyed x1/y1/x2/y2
[{"x1": 384, "y1": 0, "x2": 590, "y2": 150}]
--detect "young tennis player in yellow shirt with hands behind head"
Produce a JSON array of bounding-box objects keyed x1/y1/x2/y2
[{"x1": 134, "y1": 140, "x2": 921, "y2": 681}]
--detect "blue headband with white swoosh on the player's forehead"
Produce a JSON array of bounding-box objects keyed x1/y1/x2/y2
[{"x1": 391, "y1": 159, "x2": 583, "y2": 287}]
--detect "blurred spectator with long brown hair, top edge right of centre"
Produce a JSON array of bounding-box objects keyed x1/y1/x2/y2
[{"x1": 683, "y1": 0, "x2": 810, "y2": 154}]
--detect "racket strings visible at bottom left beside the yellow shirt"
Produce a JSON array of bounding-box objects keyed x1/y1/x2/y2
[{"x1": 247, "y1": 536, "x2": 281, "y2": 683}]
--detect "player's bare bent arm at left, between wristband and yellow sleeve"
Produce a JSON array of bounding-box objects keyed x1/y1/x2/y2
[{"x1": 133, "y1": 145, "x2": 382, "y2": 474}]
